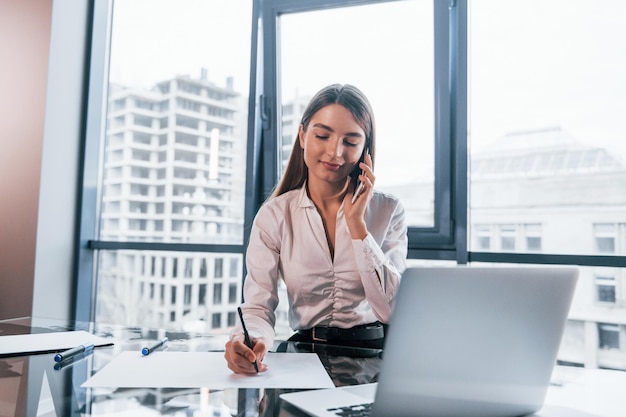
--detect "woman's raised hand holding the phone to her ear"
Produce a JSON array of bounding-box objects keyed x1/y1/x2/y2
[{"x1": 343, "y1": 153, "x2": 376, "y2": 239}]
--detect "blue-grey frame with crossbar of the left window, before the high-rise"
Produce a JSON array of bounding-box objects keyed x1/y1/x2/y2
[{"x1": 72, "y1": 0, "x2": 261, "y2": 321}]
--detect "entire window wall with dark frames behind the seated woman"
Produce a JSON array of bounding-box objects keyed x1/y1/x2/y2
[{"x1": 77, "y1": 0, "x2": 626, "y2": 369}]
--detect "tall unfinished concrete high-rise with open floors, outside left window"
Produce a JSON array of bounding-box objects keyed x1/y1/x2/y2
[{"x1": 96, "y1": 71, "x2": 247, "y2": 333}]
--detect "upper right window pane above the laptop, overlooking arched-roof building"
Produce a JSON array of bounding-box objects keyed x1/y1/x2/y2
[{"x1": 468, "y1": 0, "x2": 626, "y2": 255}]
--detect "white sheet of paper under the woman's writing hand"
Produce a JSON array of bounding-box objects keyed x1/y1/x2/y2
[{"x1": 82, "y1": 351, "x2": 335, "y2": 389}]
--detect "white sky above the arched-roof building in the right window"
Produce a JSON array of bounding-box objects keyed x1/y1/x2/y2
[{"x1": 469, "y1": 0, "x2": 626, "y2": 156}]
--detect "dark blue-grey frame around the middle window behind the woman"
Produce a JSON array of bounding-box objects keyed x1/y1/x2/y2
[{"x1": 256, "y1": 0, "x2": 467, "y2": 263}]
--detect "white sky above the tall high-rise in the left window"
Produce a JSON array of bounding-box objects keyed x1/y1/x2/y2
[{"x1": 110, "y1": 0, "x2": 252, "y2": 95}]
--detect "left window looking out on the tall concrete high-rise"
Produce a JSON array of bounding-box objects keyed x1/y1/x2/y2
[{"x1": 80, "y1": 0, "x2": 252, "y2": 332}]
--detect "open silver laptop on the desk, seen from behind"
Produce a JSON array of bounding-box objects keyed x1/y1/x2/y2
[{"x1": 281, "y1": 266, "x2": 578, "y2": 417}]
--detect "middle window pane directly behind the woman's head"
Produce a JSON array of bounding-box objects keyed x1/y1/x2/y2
[{"x1": 277, "y1": 0, "x2": 435, "y2": 227}]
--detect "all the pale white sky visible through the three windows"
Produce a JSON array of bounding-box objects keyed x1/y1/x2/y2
[{"x1": 110, "y1": 0, "x2": 626, "y2": 184}]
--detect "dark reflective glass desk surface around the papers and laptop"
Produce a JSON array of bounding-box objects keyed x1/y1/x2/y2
[{"x1": 0, "y1": 318, "x2": 626, "y2": 417}]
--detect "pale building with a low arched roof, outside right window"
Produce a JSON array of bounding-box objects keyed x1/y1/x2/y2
[{"x1": 469, "y1": 127, "x2": 626, "y2": 370}]
